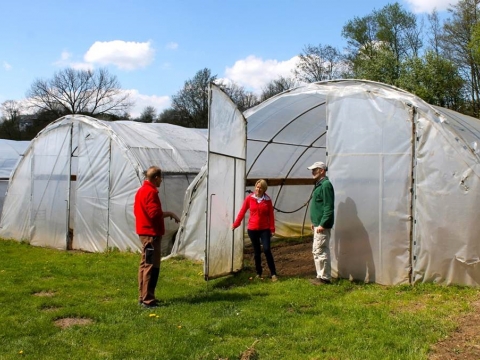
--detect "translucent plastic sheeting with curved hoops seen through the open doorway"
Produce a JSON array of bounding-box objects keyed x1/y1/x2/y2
[{"x1": 244, "y1": 89, "x2": 327, "y2": 237}]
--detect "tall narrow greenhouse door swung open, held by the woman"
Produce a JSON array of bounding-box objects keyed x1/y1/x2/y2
[{"x1": 204, "y1": 84, "x2": 247, "y2": 280}]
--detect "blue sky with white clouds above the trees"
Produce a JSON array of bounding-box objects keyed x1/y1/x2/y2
[{"x1": 0, "y1": 0, "x2": 458, "y2": 116}]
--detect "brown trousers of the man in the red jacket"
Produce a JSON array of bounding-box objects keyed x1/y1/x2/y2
[{"x1": 138, "y1": 235, "x2": 162, "y2": 305}]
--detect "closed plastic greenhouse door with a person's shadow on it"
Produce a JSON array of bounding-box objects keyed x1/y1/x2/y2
[{"x1": 327, "y1": 94, "x2": 413, "y2": 285}]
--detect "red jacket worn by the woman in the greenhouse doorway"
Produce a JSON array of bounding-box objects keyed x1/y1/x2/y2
[{"x1": 233, "y1": 194, "x2": 275, "y2": 234}]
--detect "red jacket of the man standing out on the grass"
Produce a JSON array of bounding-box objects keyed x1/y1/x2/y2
[{"x1": 133, "y1": 180, "x2": 165, "y2": 236}]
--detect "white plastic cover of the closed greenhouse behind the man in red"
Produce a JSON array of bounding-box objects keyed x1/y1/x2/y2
[{"x1": 0, "y1": 115, "x2": 207, "y2": 251}]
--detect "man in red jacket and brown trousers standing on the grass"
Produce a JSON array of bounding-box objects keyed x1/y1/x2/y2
[{"x1": 133, "y1": 166, "x2": 180, "y2": 308}]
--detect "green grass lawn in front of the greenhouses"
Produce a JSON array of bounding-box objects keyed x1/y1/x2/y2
[{"x1": 0, "y1": 241, "x2": 478, "y2": 360}]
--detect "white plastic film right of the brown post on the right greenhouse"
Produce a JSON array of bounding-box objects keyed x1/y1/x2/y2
[{"x1": 413, "y1": 114, "x2": 480, "y2": 286}]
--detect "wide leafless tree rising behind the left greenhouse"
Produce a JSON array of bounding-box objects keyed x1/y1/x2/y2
[{"x1": 27, "y1": 68, "x2": 132, "y2": 116}]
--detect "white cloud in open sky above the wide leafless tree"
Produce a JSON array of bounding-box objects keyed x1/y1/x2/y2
[{"x1": 83, "y1": 40, "x2": 155, "y2": 70}]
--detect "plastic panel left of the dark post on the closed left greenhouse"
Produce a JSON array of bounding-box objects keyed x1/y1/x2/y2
[{"x1": 30, "y1": 126, "x2": 72, "y2": 249}]
